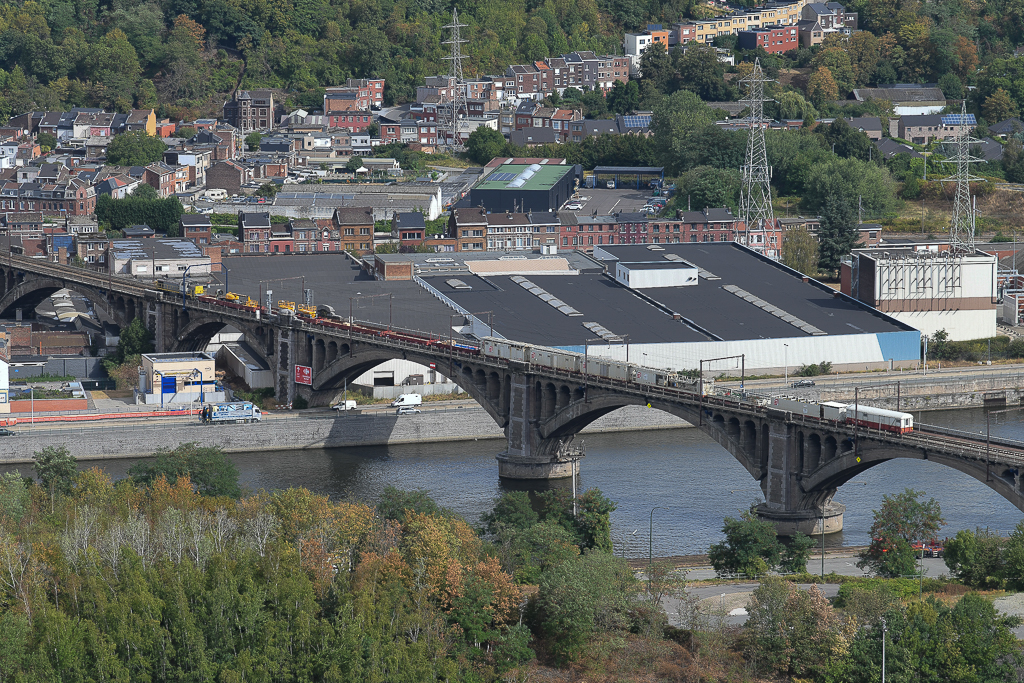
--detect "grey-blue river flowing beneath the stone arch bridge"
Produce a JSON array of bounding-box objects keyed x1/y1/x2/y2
[{"x1": 0, "y1": 409, "x2": 1024, "y2": 557}]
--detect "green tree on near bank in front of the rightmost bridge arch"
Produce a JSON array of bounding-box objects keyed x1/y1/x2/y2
[{"x1": 857, "y1": 488, "x2": 945, "y2": 578}]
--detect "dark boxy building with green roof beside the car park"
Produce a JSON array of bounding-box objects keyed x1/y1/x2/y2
[{"x1": 469, "y1": 164, "x2": 583, "y2": 213}]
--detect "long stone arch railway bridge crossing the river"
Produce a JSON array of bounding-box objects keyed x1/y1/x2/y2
[{"x1": 6, "y1": 257, "x2": 1024, "y2": 532}]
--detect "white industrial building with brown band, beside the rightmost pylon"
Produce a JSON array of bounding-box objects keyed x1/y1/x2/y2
[{"x1": 843, "y1": 247, "x2": 998, "y2": 341}]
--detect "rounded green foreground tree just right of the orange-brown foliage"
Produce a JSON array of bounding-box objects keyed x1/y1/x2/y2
[{"x1": 537, "y1": 551, "x2": 637, "y2": 661}]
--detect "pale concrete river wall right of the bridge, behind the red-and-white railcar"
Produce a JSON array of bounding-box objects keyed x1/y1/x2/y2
[{"x1": 819, "y1": 374, "x2": 1024, "y2": 412}]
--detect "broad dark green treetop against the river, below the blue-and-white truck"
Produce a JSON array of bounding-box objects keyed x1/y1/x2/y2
[{"x1": 128, "y1": 441, "x2": 242, "y2": 498}]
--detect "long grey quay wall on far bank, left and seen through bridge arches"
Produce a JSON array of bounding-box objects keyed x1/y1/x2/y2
[{"x1": 0, "y1": 407, "x2": 690, "y2": 463}]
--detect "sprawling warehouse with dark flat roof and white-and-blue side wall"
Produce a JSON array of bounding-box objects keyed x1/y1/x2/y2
[{"x1": 211, "y1": 243, "x2": 921, "y2": 374}]
